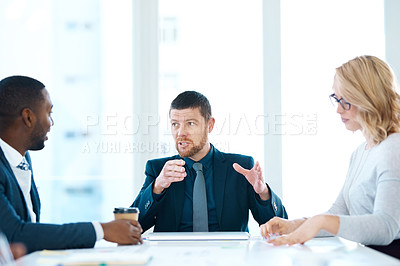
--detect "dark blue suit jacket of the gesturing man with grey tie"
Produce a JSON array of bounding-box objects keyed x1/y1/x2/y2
[{"x1": 132, "y1": 149, "x2": 287, "y2": 232}]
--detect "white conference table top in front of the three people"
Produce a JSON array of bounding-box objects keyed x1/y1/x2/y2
[{"x1": 17, "y1": 236, "x2": 400, "y2": 266}]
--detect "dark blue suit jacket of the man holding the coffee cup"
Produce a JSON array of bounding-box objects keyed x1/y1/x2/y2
[{"x1": 0, "y1": 148, "x2": 96, "y2": 253}]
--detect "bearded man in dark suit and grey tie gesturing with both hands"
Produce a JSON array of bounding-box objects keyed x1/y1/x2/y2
[{"x1": 132, "y1": 91, "x2": 287, "y2": 232}]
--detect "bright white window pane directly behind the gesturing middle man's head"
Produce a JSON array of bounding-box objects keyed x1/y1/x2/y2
[{"x1": 159, "y1": 0, "x2": 264, "y2": 162}]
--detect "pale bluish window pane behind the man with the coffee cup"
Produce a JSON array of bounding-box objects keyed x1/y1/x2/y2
[{"x1": 0, "y1": 0, "x2": 135, "y2": 223}]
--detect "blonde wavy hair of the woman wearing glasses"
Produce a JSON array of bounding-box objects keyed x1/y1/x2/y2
[{"x1": 335, "y1": 56, "x2": 400, "y2": 144}]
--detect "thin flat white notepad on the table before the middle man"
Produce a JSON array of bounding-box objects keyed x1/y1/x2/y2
[{"x1": 146, "y1": 232, "x2": 250, "y2": 241}]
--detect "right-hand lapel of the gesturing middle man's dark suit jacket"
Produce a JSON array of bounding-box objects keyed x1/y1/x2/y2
[{"x1": 213, "y1": 148, "x2": 228, "y2": 226}]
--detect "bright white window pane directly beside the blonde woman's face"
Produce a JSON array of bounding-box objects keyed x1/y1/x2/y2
[{"x1": 281, "y1": 0, "x2": 385, "y2": 218}]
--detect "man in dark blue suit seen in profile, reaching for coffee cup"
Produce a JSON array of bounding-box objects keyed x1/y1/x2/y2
[{"x1": 0, "y1": 76, "x2": 142, "y2": 253}]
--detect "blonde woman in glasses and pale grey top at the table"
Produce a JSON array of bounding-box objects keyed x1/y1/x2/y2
[{"x1": 260, "y1": 56, "x2": 400, "y2": 257}]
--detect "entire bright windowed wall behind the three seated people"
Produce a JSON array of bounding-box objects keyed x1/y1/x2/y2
[{"x1": 0, "y1": 0, "x2": 400, "y2": 234}]
